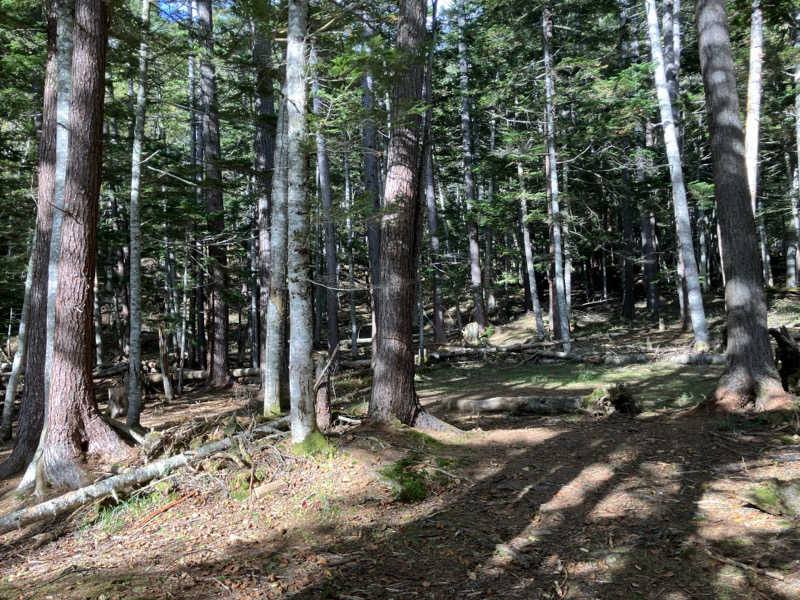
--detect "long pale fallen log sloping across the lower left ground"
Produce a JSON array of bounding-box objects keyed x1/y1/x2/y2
[{"x1": 0, "y1": 416, "x2": 289, "y2": 535}]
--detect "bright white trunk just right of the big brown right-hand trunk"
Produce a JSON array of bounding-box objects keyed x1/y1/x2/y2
[{"x1": 744, "y1": 0, "x2": 772, "y2": 285}]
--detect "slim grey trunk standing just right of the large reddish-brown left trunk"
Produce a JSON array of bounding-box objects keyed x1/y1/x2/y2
[{"x1": 125, "y1": 0, "x2": 150, "y2": 427}]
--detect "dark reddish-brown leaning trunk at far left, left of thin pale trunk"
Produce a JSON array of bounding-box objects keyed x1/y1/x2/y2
[{"x1": 0, "y1": 2, "x2": 58, "y2": 479}]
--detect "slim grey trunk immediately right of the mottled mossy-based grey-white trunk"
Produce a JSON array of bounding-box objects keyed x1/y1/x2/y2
[{"x1": 309, "y1": 44, "x2": 339, "y2": 353}]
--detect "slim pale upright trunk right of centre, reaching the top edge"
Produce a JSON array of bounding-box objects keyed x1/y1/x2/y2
[{"x1": 542, "y1": 5, "x2": 570, "y2": 352}]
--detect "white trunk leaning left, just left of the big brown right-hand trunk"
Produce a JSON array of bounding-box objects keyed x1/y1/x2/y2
[{"x1": 645, "y1": 0, "x2": 708, "y2": 350}]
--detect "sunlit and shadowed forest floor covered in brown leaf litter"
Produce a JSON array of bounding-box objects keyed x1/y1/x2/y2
[{"x1": 0, "y1": 303, "x2": 800, "y2": 600}]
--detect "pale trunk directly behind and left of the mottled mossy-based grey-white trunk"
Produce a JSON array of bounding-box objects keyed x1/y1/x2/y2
[{"x1": 261, "y1": 83, "x2": 289, "y2": 416}]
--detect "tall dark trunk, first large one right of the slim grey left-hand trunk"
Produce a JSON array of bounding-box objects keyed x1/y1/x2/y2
[{"x1": 197, "y1": 0, "x2": 230, "y2": 387}]
